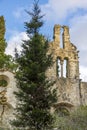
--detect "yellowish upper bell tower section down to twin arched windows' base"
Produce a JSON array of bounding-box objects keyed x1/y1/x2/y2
[{"x1": 52, "y1": 25, "x2": 79, "y2": 79}]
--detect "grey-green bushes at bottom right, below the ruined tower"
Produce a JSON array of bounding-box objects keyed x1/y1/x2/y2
[{"x1": 54, "y1": 106, "x2": 87, "y2": 130}]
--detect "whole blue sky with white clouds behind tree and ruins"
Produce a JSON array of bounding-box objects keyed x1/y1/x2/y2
[{"x1": 0, "y1": 0, "x2": 87, "y2": 81}]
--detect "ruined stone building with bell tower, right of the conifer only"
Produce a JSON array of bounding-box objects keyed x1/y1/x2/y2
[{"x1": 47, "y1": 25, "x2": 87, "y2": 109}]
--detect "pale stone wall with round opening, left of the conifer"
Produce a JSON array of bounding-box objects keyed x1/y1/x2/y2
[{"x1": 0, "y1": 70, "x2": 16, "y2": 128}]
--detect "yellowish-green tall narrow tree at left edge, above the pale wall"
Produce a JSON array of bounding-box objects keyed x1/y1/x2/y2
[{"x1": 0, "y1": 16, "x2": 15, "y2": 71}]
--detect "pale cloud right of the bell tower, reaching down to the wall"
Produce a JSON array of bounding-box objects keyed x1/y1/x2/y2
[{"x1": 66, "y1": 14, "x2": 87, "y2": 81}]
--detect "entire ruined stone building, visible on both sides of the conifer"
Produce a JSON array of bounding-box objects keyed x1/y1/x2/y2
[{"x1": 0, "y1": 18, "x2": 87, "y2": 127}]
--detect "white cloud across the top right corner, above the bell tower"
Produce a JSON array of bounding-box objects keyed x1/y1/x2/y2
[{"x1": 42, "y1": 0, "x2": 87, "y2": 20}]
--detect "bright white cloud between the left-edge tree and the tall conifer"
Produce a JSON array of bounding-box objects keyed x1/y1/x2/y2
[{"x1": 6, "y1": 32, "x2": 28, "y2": 56}]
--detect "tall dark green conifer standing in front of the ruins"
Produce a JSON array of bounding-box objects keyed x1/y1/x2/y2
[{"x1": 12, "y1": 1, "x2": 56, "y2": 130}]
